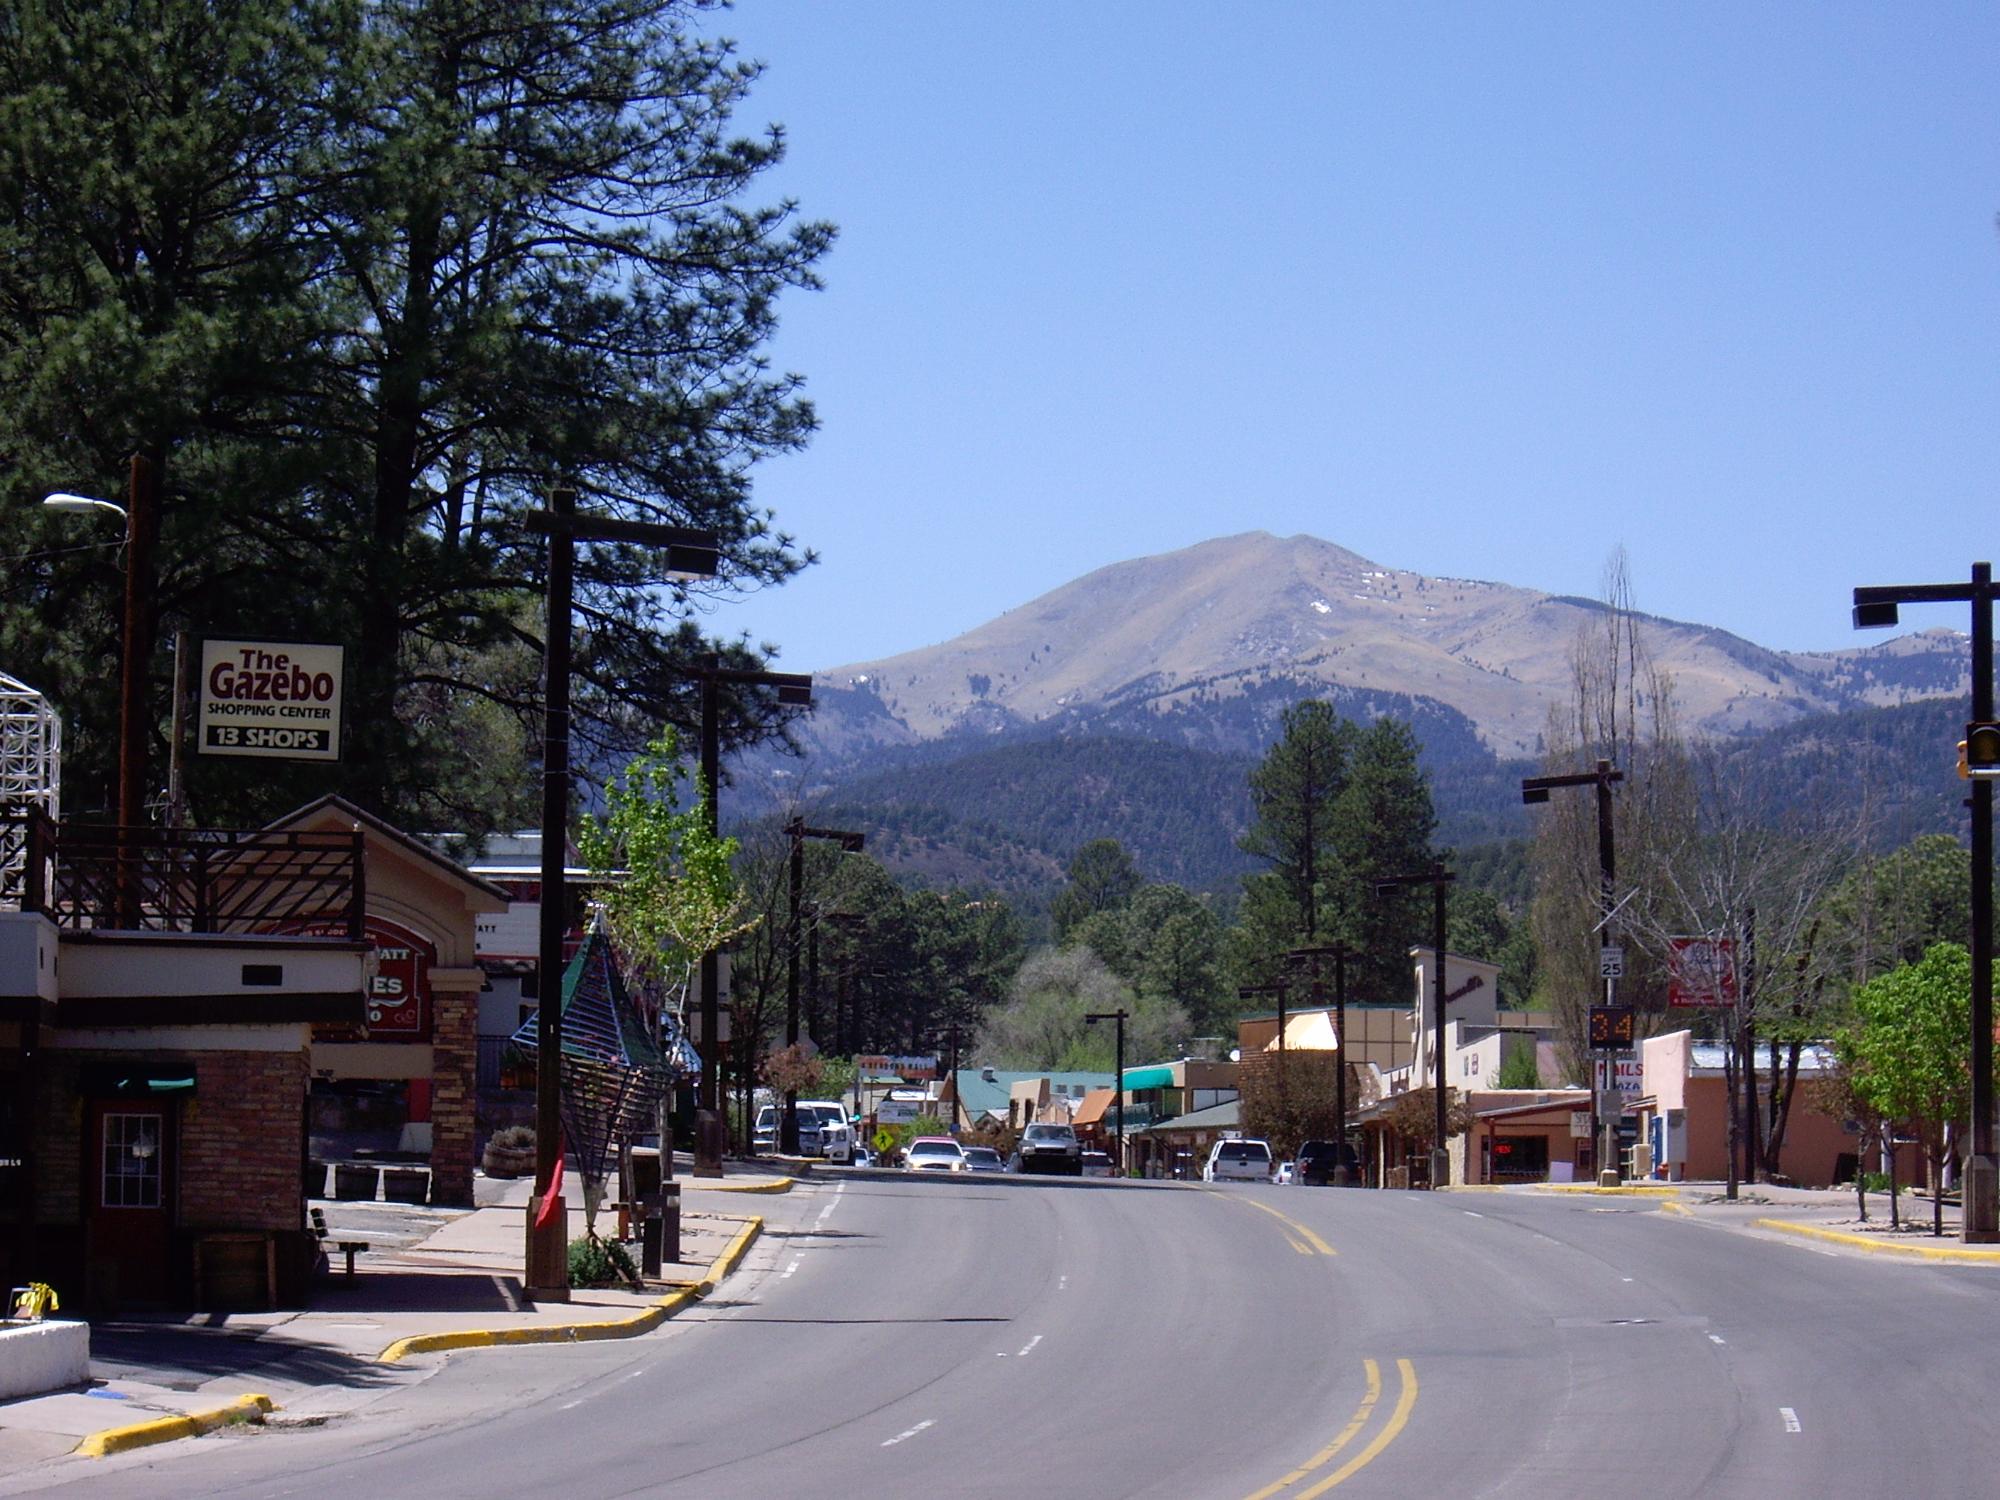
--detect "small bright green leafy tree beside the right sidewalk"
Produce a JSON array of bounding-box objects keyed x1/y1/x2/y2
[{"x1": 1838, "y1": 942, "x2": 1972, "y2": 1234}]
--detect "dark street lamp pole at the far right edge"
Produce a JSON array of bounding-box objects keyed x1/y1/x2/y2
[{"x1": 1854, "y1": 562, "x2": 2000, "y2": 1244}]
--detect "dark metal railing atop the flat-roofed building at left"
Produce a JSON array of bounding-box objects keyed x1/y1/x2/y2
[{"x1": 0, "y1": 808, "x2": 368, "y2": 942}]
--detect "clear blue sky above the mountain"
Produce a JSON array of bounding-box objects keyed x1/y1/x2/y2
[{"x1": 708, "y1": 0, "x2": 2000, "y2": 670}]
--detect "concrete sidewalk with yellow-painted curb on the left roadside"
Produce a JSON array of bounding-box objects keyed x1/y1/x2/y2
[{"x1": 0, "y1": 1162, "x2": 792, "y2": 1476}]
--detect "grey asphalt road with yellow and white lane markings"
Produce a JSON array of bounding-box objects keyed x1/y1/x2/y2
[{"x1": 23, "y1": 1174, "x2": 2000, "y2": 1500}]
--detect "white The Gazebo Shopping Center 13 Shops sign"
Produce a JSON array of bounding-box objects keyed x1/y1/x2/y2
[{"x1": 194, "y1": 640, "x2": 342, "y2": 760}]
